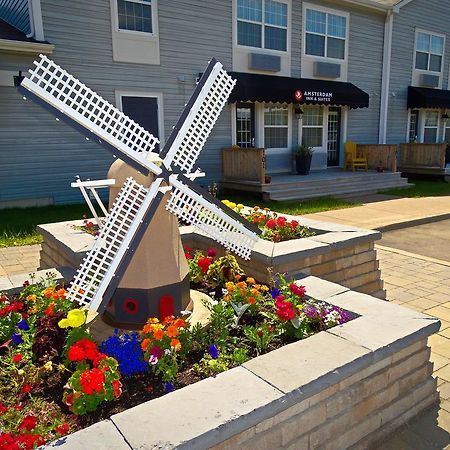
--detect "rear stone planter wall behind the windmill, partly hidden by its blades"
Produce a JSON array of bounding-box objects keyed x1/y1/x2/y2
[{"x1": 38, "y1": 216, "x2": 386, "y2": 298}]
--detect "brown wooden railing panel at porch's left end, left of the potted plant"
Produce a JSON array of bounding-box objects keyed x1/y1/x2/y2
[{"x1": 222, "y1": 148, "x2": 266, "y2": 183}]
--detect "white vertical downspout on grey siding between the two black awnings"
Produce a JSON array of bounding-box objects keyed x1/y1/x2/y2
[{"x1": 378, "y1": 10, "x2": 394, "y2": 144}]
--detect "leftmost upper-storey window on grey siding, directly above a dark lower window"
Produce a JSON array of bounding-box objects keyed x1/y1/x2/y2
[{"x1": 117, "y1": 0, "x2": 153, "y2": 33}]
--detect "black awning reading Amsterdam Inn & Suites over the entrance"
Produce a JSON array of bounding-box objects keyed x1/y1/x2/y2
[{"x1": 228, "y1": 72, "x2": 369, "y2": 108}]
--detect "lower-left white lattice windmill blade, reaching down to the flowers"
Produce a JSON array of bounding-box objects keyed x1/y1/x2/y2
[{"x1": 67, "y1": 177, "x2": 162, "y2": 312}]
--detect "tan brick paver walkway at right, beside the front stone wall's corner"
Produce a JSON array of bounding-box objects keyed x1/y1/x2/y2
[{"x1": 377, "y1": 248, "x2": 450, "y2": 450}]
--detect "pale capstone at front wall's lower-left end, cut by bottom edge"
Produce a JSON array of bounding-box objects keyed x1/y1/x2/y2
[{"x1": 44, "y1": 420, "x2": 131, "y2": 450}]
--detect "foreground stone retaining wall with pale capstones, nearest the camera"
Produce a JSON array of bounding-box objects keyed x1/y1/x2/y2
[{"x1": 50, "y1": 277, "x2": 440, "y2": 450}]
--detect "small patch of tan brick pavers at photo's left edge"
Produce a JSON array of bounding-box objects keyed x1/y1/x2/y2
[{"x1": 0, "y1": 244, "x2": 41, "y2": 277}]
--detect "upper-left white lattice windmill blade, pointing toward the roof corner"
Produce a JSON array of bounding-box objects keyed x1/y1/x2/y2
[{"x1": 21, "y1": 55, "x2": 161, "y2": 175}]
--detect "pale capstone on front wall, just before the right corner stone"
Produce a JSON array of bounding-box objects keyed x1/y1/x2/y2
[{"x1": 244, "y1": 332, "x2": 370, "y2": 394}]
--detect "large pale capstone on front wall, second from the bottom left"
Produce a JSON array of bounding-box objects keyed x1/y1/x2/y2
[{"x1": 111, "y1": 367, "x2": 282, "y2": 449}]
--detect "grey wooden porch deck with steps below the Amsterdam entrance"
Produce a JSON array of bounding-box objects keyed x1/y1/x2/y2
[{"x1": 221, "y1": 168, "x2": 408, "y2": 201}]
